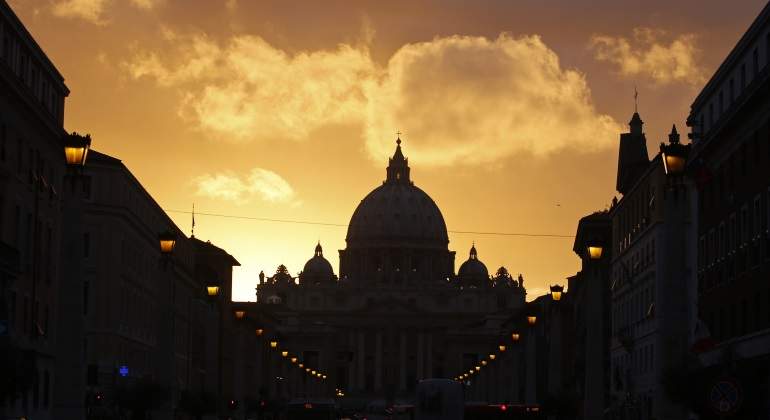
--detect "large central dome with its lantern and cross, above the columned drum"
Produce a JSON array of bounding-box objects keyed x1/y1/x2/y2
[{"x1": 346, "y1": 139, "x2": 449, "y2": 249}]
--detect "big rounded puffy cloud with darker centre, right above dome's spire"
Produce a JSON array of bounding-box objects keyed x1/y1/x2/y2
[{"x1": 365, "y1": 34, "x2": 621, "y2": 165}]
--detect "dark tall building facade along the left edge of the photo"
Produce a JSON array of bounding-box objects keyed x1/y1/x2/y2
[{"x1": 0, "y1": 2, "x2": 69, "y2": 419}]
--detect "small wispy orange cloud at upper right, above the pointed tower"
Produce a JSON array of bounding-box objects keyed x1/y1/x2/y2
[{"x1": 590, "y1": 28, "x2": 706, "y2": 85}]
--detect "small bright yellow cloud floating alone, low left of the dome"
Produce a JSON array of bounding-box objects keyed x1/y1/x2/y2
[{"x1": 193, "y1": 168, "x2": 298, "y2": 203}]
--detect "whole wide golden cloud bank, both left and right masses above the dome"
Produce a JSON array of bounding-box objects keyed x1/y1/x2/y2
[{"x1": 123, "y1": 34, "x2": 622, "y2": 166}]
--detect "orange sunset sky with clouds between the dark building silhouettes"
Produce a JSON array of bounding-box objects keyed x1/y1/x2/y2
[{"x1": 9, "y1": 0, "x2": 765, "y2": 300}]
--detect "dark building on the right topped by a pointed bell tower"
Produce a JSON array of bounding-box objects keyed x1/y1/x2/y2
[{"x1": 609, "y1": 113, "x2": 695, "y2": 419}]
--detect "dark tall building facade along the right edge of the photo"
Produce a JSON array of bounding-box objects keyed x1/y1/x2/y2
[{"x1": 688, "y1": 5, "x2": 770, "y2": 418}]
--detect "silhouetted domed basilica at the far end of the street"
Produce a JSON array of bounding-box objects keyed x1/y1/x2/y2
[{"x1": 253, "y1": 140, "x2": 526, "y2": 401}]
